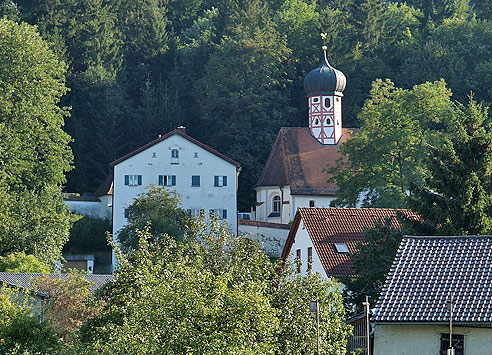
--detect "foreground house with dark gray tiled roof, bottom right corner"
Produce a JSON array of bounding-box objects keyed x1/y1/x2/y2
[{"x1": 373, "y1": 236, "x2": 492, "y2": 355}]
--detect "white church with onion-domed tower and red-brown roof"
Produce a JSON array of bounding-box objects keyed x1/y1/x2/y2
[{"x1": 255, "y1": 47, "x2": 352, "y2": 223}]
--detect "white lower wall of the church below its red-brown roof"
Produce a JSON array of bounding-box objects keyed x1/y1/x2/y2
[{"x1": 256, "y1": 185, "x2": 335, "y2": 223}]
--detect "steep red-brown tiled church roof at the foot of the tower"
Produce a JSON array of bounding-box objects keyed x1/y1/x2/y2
[{"x1": 256, "y1": 127, "x2": 352, "y2": 195}]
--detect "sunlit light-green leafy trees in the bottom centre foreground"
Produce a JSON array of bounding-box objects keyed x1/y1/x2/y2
[{"x1": 81, "y1": 219, "x2": 348, "y2": 354}]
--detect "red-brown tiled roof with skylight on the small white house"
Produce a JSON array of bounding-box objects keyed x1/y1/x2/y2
[{"x1": 282, "y1": 207, "x2": 418, "y2": 277}]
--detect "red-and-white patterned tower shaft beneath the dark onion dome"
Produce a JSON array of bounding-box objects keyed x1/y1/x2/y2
[{"x1": 309, "y1": 96, "x2": 336, "y2": 144}]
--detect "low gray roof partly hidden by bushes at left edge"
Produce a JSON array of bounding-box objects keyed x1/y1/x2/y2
[{"x1": 0, "y1": 272, "x2": 114, "y2": 293}]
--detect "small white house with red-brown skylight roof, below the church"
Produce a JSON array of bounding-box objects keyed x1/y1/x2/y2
[{"x1": 282, "y1": 207, "x2": 416, "y2": 279}]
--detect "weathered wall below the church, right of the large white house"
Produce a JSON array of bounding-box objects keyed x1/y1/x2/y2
[{"x1": 238, "y1": 221, "x2": 289, "y2": 259}]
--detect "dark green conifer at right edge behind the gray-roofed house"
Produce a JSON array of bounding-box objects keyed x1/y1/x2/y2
[{"x1": 407, "y1": 98, "x2": 492, "y2": 235}]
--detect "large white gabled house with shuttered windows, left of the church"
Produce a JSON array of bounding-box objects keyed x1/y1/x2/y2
[{"x1": 110, "y1": 127, "x2": 241, "y2": 258}]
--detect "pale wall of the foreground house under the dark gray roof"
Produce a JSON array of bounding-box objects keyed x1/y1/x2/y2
[{"x1": 374, "y1": 324, "x2": 492, "y2": 355}]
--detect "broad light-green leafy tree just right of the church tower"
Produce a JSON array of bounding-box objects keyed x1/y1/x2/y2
[{"x1": 330, "y1": 80, "x2": 452, "y2": 208}]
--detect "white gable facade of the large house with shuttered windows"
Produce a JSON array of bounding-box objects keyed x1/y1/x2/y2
[{"x1": 113, "y1": 135, "x2": 237, "y2": 249}]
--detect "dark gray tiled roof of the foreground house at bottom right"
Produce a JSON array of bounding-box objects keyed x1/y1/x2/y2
[{"x1": 374, "y1": 236, "x2": 492, "y2": 323}]
